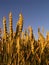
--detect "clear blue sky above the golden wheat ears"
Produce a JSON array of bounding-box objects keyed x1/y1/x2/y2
[{"x1": 0, "y1": 0, "x2": 49, "y2": 37}]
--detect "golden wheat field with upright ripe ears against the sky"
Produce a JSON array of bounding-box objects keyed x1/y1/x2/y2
[{"x1": 0, "y1": 12, "x2": 49, "y2": 65}]
